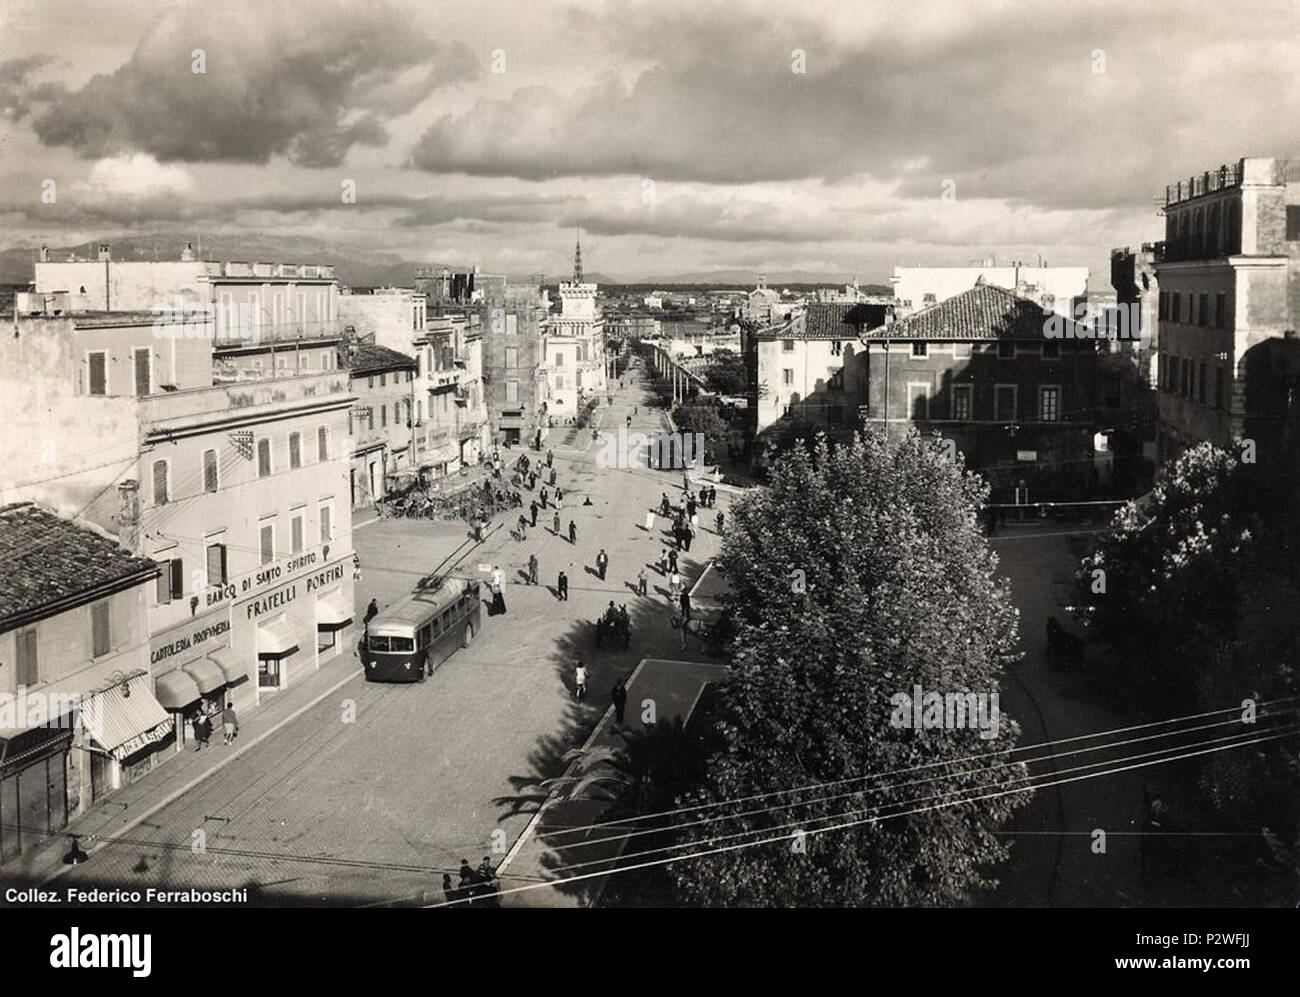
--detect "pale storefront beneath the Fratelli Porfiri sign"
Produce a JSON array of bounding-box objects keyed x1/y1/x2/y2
[{"x1": 226, "y1": 547, "x2": 354, "y2": 706}]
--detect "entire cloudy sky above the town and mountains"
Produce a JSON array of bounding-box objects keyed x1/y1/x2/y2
[{"x1": 0, "y1": 0, "x2": 1300, "y2": 280}]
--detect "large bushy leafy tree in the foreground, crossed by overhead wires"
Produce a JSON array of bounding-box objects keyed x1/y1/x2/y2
[{"x1": 670, "y1": 433, "x2": 1027, "y2": 906}]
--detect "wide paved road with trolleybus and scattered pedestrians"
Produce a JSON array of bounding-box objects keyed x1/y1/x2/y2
[{"x1": 61, "y1": 363, "x2": 723, "y2": 903}]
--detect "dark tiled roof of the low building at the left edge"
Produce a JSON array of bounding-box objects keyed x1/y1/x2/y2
[{"x1": 0, "y1": 502, "x2": 159, "y2": 632}]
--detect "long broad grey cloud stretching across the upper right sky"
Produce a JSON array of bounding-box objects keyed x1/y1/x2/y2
[{"x1": 411, "y1": 0, "x2": 1300, "y2": 208}]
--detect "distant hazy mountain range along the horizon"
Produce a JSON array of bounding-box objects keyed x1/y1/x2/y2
[{"x1": 0, "y1": 233, "x2": 889, "y2": 292}]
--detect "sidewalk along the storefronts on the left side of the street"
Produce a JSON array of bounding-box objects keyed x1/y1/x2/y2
[{"x1": 4, "y1": 645, "x2": 361, "y2": 883}]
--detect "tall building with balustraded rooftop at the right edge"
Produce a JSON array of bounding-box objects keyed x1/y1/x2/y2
[{"x1": 1154, "y1": 159, "x2": 1300, "y2": 461}]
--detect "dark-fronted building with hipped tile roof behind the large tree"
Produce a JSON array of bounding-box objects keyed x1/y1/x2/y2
[{"x1": 861, "y1": 281, "x2": 1099, "y2": 500}]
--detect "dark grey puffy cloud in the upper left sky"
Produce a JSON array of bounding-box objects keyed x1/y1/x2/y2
[{"x1": 34, "y1": 0, "x2": 480, "y2": 166}]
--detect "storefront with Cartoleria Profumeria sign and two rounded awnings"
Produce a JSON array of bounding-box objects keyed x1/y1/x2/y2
[{"x1": 150, "y1": 606, "x2": 250, "y2": 751}]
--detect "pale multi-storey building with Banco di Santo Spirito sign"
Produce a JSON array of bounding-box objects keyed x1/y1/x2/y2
[{"x1": 0, "y1": 288, "x2": 354, "y2": 745}]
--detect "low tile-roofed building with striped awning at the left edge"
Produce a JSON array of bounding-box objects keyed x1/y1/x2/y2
[{"x1": 0, "y1": 503, "x2": 163, "y2": 863}]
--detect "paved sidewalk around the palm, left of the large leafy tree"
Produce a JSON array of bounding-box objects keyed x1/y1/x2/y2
[{"x1": 483, "y1": 658, "x2": 727, "y2": 907}]
